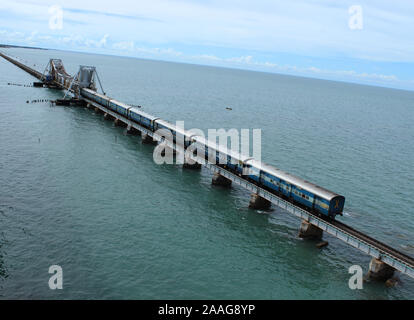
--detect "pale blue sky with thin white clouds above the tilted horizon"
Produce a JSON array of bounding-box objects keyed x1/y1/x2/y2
[{"x1": 0, "y1": 0, "x2": 414, "y2": 90}]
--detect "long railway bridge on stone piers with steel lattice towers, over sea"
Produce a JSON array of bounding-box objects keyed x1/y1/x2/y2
[{"x1": 0, "y1": 52, "x2": 414, "y2": 280}]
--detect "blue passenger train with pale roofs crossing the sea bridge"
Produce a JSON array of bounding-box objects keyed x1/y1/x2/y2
[{"x1": 81, "y1": 89, "x2": 345, "y2": 219}]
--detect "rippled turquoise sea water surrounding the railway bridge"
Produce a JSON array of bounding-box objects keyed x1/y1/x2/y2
[{"x1": 0, "y1": 49, "x2": 414, "y2": 299}]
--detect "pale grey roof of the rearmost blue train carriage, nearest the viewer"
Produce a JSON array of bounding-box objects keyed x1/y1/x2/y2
[{"x1": 247, "y1": 159, "x2": 342, "y2": 200}]
